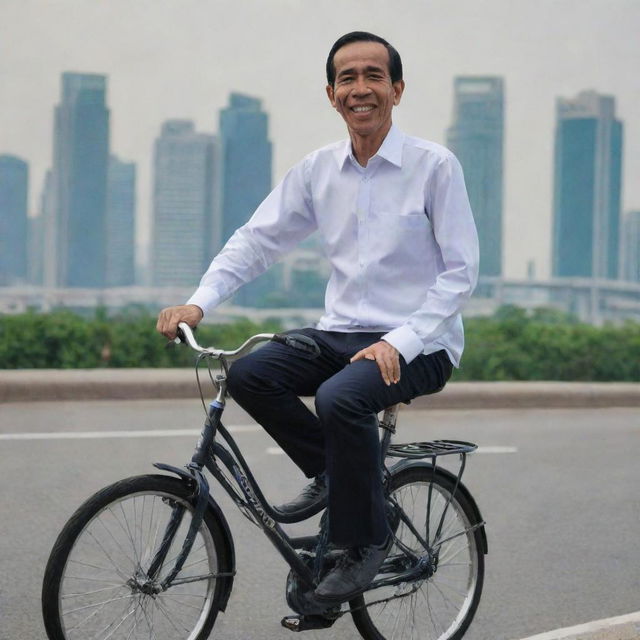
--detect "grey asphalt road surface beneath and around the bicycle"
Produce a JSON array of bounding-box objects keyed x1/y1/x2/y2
[{"x1": 0, "y1": 400, "x2": 640, "y2": 640}]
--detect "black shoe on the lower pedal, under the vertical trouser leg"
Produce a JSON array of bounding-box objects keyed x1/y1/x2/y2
[{"x1": 314, "y1": 536, "x2": 393, "y2": 602}]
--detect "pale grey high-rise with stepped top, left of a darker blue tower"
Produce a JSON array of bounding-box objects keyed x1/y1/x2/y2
[{"x1": 152, "y1": 120, "x2": 216, "y2": 287}]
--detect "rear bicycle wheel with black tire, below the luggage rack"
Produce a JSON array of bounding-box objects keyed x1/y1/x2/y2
[{"x1": 351, "y1": 465, "x2": 484, "y2": 640}]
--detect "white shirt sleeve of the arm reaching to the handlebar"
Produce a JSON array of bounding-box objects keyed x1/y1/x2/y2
[{"x1": 187, "y1": 159, "x2": 317, "y2": 315}]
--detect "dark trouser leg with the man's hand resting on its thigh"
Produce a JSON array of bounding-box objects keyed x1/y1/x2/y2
[{"x1": 316, "y1": 352, "x2": 451, "y2": 546}]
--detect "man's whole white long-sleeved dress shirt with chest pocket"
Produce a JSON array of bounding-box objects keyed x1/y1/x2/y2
[{"x1": 188, "y1": 126, "x2": 478, "y2": 367}]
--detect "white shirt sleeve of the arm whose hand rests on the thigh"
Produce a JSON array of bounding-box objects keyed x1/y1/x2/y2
[{"x1": 382, "y1": 154, "x2": 479, "y2": 362}]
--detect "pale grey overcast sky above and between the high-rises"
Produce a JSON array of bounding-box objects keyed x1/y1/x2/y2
[{"x1": 0, "y1": 0, "x2": 640, "y2": 277}]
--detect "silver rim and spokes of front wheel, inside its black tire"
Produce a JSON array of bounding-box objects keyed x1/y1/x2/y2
[{"x1": 51, "y1": 482, "x2": 218, "y2": 640}]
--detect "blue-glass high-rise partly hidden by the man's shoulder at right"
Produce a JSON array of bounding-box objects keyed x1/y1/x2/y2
[{"x1": 447, "y1": 76, "x2": 504, "y2": 276}]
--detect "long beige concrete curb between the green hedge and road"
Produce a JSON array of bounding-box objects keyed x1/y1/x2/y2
[{"x1": 0, "y1": 369, "x2": 640, "y2": 409}]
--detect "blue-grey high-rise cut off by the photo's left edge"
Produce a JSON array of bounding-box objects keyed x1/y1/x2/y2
[{"x1": 0, "y1": 155, "x2": 29, "y2": 286}]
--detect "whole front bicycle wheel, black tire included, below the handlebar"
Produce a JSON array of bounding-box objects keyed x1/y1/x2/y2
[{"x1": 42, "y1": 475, "x2": 233, "y2": 640}]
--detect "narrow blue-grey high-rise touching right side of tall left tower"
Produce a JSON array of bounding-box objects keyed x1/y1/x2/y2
[{"x1": 105, "y1": 156, "x2": 136, "y2": 287}]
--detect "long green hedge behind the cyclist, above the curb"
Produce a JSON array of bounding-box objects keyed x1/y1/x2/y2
[{"x1": 0, "y1": 307, "x2": 640, "y2": 382}]
